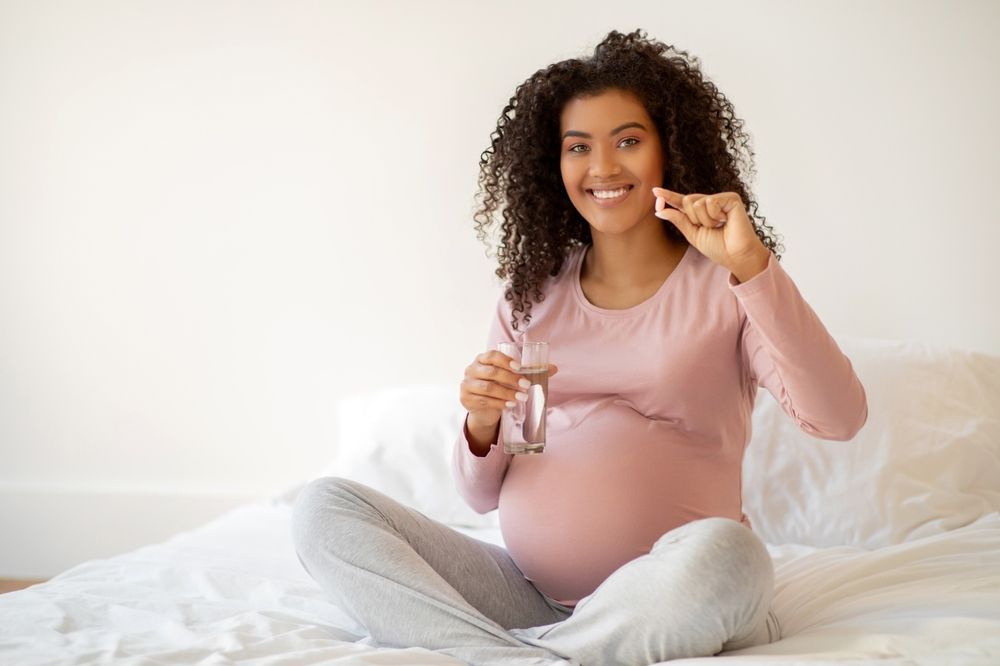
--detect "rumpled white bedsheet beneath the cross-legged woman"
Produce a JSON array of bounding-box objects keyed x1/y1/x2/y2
[{"x1": 0, "y1": 497, "x2": 1000, "y2": 666}]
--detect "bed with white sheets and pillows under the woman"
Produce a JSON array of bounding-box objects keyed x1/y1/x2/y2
[{"x1": 0, "y1": 339, "x2": 1000, "y2": 665}]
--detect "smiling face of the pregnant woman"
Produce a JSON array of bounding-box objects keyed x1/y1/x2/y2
[{"x1": 559, "y1": 89, "x2": 663, "y2": 233}]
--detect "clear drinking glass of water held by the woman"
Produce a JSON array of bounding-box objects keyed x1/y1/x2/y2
[{"x1": 497, "y1": 342, "x2": 549, "y2": 453}]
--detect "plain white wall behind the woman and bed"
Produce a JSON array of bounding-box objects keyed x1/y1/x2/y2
[{"x1": 0, "y1": 0, "x2": 1000, "y2": 576}]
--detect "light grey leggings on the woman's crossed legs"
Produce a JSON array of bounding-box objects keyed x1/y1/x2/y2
[{"x1": 292, "y1": 477, "x2": 779, "y2": 666}]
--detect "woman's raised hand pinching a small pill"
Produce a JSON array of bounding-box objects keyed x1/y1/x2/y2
[{"x1": 653, "y1": 187, "x2": 771, "y2": 282}]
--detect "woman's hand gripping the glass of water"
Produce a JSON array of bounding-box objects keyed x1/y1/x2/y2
[{"x1": 459, "y1": 350, "x2": 559, "y2": 428}]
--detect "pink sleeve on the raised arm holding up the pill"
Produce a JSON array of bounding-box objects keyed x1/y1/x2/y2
[{"x1": 729, "y1": 254, "x2": 868, "y2": 441}]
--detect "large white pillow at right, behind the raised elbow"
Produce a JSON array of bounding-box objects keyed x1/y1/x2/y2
[{"x1": 743, "y1": 338, "x2": 1000, "y2": 548}]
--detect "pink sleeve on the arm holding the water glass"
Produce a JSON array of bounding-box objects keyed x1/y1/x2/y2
[{"x1": 452, "y1": 294, "x2": 515, "y2": 513}]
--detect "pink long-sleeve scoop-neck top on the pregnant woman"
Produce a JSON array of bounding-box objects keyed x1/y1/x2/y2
[{"x1": 452, "y1": 241, "x2": 868, "y2": 606}]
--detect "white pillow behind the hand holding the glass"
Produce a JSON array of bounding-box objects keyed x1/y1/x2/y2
[{"x1": 321, "y1": 383, "x2": 499, "y2": 527}]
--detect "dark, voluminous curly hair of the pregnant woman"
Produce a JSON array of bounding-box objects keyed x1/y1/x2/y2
[{"x1": 473, "y1": 30, "x2": 784, "y2": 330}]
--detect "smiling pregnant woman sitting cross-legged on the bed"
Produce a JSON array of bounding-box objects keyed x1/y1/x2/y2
[{"x1": 293, "y1": 31, "x2": 868, "y2": 666}]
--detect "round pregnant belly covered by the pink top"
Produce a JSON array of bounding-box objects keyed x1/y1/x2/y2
[{"x1": 499, "y1": 396, "x2": 741, "y2": 600}]
